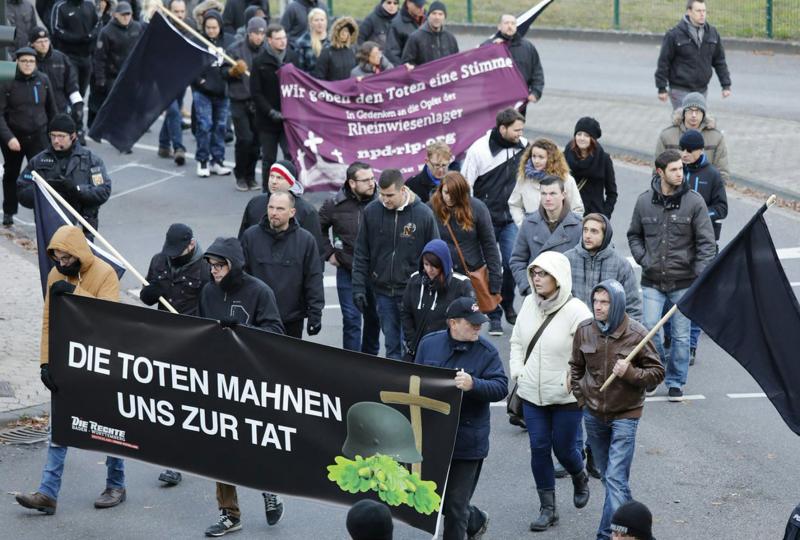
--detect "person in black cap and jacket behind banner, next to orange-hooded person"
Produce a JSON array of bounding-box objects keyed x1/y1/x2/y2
[{"x1": 139, "y1": 223, "x2": 211, "y2": 486}]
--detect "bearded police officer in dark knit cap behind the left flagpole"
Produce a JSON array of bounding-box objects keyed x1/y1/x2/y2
[{"x1": 17, "y1": 113, "x2": 111, "y2": 234}]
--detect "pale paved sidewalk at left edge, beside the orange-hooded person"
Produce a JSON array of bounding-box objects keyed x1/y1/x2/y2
[{"x1": 0, "y1": 235, "x2": 50, "y2": 418}]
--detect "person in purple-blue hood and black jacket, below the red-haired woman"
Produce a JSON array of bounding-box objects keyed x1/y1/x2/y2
[{"x1": 400, "y1": 238, "x2": 474, "y2": 362}]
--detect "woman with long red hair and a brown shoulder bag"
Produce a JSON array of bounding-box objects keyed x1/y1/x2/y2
[{"x1": 429, "y1": 171, "x2": 503, "y2": 335}]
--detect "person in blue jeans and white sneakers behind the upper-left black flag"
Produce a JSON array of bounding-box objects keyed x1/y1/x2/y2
[{"x1": 192, "y1": 9, "x2": 231, "y2": 177}]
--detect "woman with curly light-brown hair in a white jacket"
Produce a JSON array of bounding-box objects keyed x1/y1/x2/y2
[{"x1": 508, "y1": 137, "x2": 583, "y2": 227}]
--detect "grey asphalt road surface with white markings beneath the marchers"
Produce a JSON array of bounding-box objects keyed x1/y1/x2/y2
[{"x1": 0, "y1": 32, "x2": 800, "y2": 540}]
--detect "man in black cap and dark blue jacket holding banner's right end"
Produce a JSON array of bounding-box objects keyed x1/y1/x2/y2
[{"x1": 415, "y1": 297, "x2": 508, "y2": 540}]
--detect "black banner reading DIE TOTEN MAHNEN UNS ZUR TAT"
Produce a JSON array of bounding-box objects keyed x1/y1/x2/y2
[{"x1": 50, "y1": 295, "x2": 461, "y2": 533}]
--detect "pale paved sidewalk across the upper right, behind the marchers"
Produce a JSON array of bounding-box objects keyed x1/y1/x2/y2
[{"x1": 527, "y1": 90, "x2": 800, "y2": 200}]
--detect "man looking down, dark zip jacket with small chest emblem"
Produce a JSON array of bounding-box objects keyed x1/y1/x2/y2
[{"x1": 353, "y1": 169, "x2": 439, "y2": 359}]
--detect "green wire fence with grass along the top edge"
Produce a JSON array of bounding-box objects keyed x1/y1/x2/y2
[{"x1": 290, "y1": 0, "x2": 800, "y2": 40}]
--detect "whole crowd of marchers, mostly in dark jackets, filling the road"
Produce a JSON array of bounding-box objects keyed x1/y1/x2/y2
[{"x1": 0, "y1": 0, "x2": 730, "y2": 540}]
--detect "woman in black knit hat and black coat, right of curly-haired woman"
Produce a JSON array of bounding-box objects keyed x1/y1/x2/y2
[{"x1": 564, "y1": 116, "x2": 617, "y2": 218}]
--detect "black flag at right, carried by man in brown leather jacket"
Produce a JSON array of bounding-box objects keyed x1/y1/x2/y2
[{"x1": 678, "y1": 205, "x2": 800, "y2": 435}]
